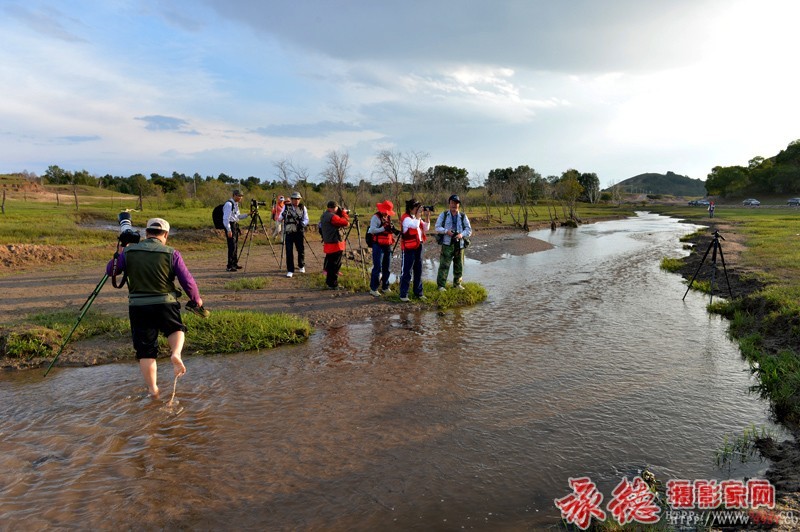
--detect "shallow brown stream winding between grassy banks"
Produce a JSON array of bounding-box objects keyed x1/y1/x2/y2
[{"x1": 0, "y1": 215, "x2": 780, "y2": 530}]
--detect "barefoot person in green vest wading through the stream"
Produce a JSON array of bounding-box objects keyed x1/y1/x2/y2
[{"x1": 106, "y1": 218, "x2": 203, "y2": 399}]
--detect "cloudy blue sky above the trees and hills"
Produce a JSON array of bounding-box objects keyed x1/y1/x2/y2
[{"x1": 0, "y1": 0, "x2": 800, "y2": 187}]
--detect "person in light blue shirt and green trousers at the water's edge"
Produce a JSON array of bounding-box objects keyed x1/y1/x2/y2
[{"x1": 436, "y1": 194, "x2": 472, "y2": 292}]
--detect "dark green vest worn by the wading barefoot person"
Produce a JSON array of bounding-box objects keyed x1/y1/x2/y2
[{"x1": 123, "y1": 238, "x2": 180, "y2": 307}]
